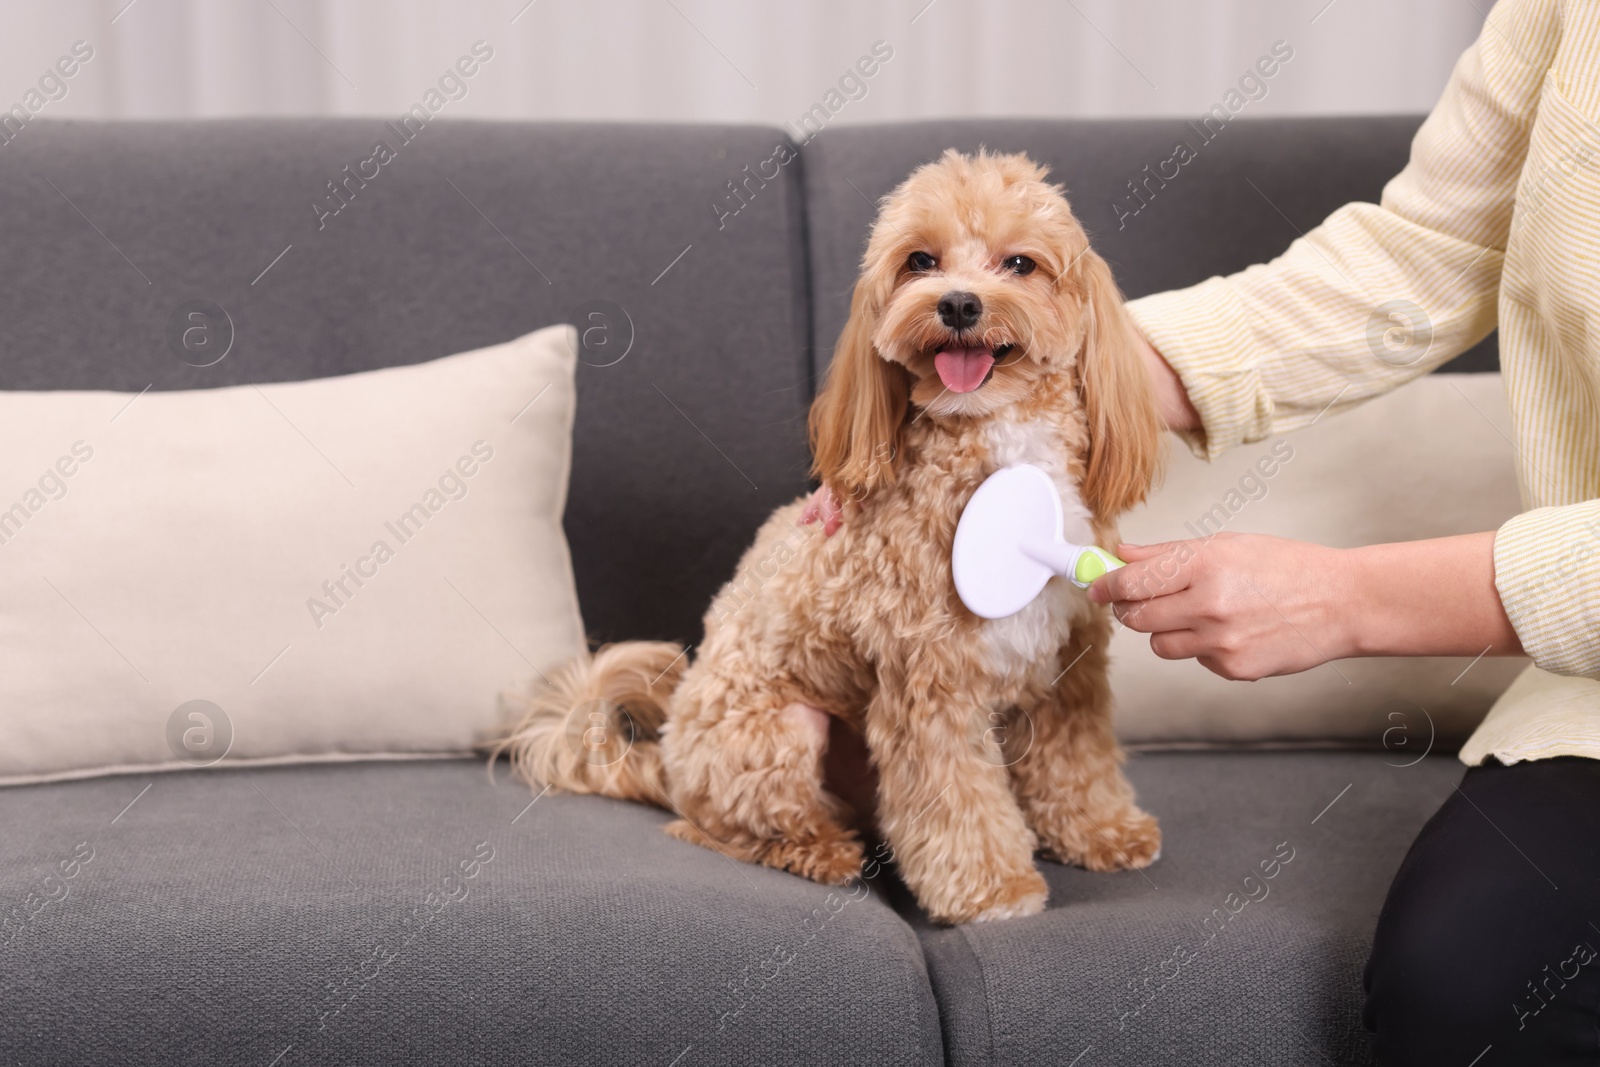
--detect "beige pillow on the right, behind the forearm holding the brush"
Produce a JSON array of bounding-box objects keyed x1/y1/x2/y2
[{"x1": 1112, "y1": 374, "x2": 1528, "y2": 751}]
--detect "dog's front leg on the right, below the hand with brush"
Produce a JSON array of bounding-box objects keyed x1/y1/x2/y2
[{"x1": 1005, "y1": 621, "x2": 1162, "y2": 870}]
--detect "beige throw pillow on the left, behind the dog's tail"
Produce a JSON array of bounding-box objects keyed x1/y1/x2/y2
[{"x1": 0, "y1": 326, "x2": 584, "y2": 784}]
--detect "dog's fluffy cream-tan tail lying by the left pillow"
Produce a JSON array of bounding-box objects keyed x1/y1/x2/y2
[{"x1": 490, "y1": 641, "x2": 685, "y2": 808}]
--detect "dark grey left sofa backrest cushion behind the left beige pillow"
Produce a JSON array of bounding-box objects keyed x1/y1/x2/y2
[{"x1": 0, "y1": 120, "x2": 808, "y2": 640}]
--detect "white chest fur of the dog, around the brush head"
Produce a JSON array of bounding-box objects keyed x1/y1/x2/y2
[{"x1": 982, "y1": 418, "x2": 1094, "y2": 680}]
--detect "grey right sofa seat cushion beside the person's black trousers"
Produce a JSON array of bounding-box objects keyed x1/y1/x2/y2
[{"x1": 914, "y1": 752, "x2": 1465, "y2": 1067}]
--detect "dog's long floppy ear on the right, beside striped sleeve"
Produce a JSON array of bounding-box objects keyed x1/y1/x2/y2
[{"x1": 1077, "y1": 250, "x2": 1162, "y2": 518}]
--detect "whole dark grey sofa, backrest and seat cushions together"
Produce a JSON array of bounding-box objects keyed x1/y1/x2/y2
[{"x1": 0, "y1": 118, "x2": 1496, "y2": 1067}]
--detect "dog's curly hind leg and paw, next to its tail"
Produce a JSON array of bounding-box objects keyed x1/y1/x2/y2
[{"x1": 662, "y1": 678, "x2": 862, "y2": 885}]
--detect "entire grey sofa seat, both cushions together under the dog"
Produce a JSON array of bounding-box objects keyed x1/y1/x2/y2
[{"x1": 0, "y1": 752, "x2": 1462, "y2": 1067}]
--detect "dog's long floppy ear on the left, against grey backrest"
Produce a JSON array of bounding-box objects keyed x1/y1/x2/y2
[{"x1": 810, "y1": 274, "x2": 910, "y2": 501}]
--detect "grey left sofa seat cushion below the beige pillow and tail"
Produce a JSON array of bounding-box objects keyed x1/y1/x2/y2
[{"x1": 0, "y1": 760, "x2": 941, "y2": 1067}]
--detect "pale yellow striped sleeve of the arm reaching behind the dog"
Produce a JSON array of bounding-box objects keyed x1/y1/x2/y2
[{"x1": 1128, "y1": 0, "x2": 1555, "y2": 459}]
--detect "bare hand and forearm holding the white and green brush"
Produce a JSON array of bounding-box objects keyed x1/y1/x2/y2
[{"x1": 1090, "y1": 533, "x2": 1522, "y2": 680}]
